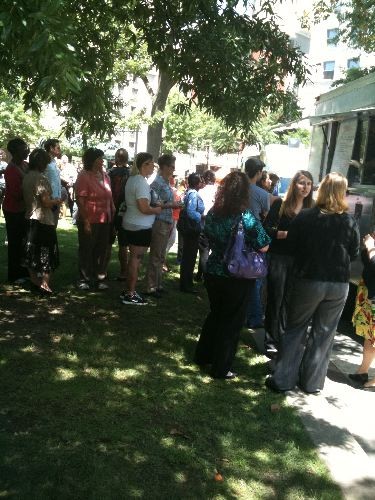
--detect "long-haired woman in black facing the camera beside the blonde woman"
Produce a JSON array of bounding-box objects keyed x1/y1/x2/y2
[{"x1": 264, "y1": 170, "x2": 313, "y2": 358}]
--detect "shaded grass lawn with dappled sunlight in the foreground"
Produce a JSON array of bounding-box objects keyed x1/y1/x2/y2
[{"x1": 0, "y1": 219, "x2": 342, "y2": 500}]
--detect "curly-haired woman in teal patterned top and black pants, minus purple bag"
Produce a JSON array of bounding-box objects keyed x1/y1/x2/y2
[{"x1": 195, "y1": 172, "x2": 271, "y2": 379}]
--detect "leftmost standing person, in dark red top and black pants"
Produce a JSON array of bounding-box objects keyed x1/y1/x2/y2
[{"x1": 3, "y1": 137, "x2": 30, "y2": 283}]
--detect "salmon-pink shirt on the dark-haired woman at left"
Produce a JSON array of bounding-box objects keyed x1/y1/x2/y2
[{"x1": 75, "y1": 170, "x2": 115, "y2": 224}]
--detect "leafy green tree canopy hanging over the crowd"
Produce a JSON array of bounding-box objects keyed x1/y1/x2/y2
[{"x1": 0, "y1": 0, "x2": 305, "y2": 153}]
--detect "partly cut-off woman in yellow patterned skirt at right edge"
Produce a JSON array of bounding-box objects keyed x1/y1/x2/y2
[{"x1": 349, "y1": 234, "x2": 375, "y2": 387}]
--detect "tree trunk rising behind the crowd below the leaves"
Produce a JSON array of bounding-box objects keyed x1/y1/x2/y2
[{"x1": 147, "y1": 70, "x2": 173, "y2": 160}]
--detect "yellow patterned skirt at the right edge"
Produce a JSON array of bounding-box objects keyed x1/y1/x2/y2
[{"x1": 352, "y1": 281, "x2": 375, "y2": 343}]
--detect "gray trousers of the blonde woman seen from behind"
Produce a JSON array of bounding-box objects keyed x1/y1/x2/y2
[{"x1": 273, "y1": 279, "x2": 349, "y2": 392}]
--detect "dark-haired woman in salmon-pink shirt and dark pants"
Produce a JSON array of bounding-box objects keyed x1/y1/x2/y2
[{"x1": 75, "y1": 148, "x2": 115, "y2": 290}]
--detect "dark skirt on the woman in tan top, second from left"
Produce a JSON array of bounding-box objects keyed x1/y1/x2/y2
[{"x1": 24, "y1": 219, "x2": 59, "y2": 274}]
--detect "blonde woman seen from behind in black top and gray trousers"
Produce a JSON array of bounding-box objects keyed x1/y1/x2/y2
[{"x1": 266, "y1": 172, "x2": 359, "y2": 393}]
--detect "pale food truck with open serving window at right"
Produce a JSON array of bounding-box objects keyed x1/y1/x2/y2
[{"x1": 309, "y1": 73, "x2": 375, "y2": 284}]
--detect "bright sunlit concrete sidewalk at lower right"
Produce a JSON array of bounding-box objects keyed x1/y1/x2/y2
[{"x1": 250, "y1": 330, "x2": 375, "y2": 500}]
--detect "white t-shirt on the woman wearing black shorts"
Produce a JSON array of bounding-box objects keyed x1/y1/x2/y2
[{"x1": 122, "y1": 174, "x2": 155, "y2": 231}]
